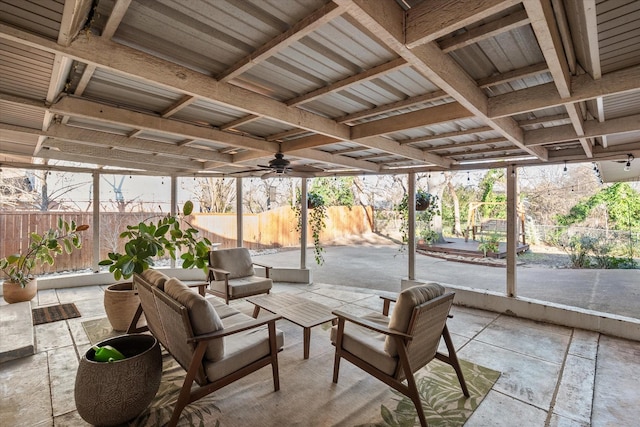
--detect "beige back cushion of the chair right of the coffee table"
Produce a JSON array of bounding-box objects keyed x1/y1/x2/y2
[{"x1": 384, "y1": 282, "x2": 444, "y2": 357}]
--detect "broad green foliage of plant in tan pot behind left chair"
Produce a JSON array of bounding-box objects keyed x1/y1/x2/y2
[{"x1": 99, "y1": 201, "x2": 211, "y2": 280}]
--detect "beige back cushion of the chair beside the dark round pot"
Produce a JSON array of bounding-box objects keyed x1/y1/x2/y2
[{"x1": 164, "y1": 277, "x2": 224, "y2": 362}]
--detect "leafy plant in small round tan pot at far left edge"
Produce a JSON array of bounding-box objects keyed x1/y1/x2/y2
[{"x1": 0, "y1": 218, "x2": 89, "y2": 303}]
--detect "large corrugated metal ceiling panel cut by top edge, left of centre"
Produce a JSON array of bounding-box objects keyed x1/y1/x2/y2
[{"x1": 104, "y1": 0, "x2": 326, "y2": 75}]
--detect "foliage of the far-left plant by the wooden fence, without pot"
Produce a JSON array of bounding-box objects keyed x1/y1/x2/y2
[{"x1": 0, "y1": 218, "x2": 89, "y2": 288}]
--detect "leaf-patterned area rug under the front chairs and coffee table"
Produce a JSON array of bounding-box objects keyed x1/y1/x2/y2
[{"x1": 83, "y1": 321, "x2": 500, "y2": 427}]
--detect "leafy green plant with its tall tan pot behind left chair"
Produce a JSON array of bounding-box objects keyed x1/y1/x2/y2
[{"x1": 99, "y1": 201, "x2": 211, "y2": 331}]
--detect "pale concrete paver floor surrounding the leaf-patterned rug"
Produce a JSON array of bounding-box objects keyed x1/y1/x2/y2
[{"x1": 0, "y1": 283, "x2": 640, "y2": 426}]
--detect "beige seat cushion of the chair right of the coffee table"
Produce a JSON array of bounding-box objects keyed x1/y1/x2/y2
[{"x1": 331, "y1": 313, "x2": 398, "y2": 375}]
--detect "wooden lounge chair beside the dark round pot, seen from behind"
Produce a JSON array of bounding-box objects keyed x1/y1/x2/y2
[{"x1": 128, "y1": 270, "x2": 284, "y2": 427}]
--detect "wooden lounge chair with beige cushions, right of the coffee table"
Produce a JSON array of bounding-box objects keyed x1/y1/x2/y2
[{"x1": 331, "y1": 283, "x2": 469, "y2": 427}]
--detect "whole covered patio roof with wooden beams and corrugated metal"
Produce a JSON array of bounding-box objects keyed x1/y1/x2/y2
[{"x1": 0, "y1": 0, "x2": 640, "y2": 181}]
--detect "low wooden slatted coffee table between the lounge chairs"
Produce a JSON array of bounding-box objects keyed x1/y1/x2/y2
[{"x1": 247, "y1": 294, "x2": 337, "y2": 359}]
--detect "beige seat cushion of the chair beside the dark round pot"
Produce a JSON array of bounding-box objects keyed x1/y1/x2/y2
[{"x1": 204, "y1": 326, "x2": 284, "y2": 381}]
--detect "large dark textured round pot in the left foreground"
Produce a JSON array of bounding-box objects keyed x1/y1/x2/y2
[{"x1": 74, "y1": 334, "x2": 162, "y2": 426}]
